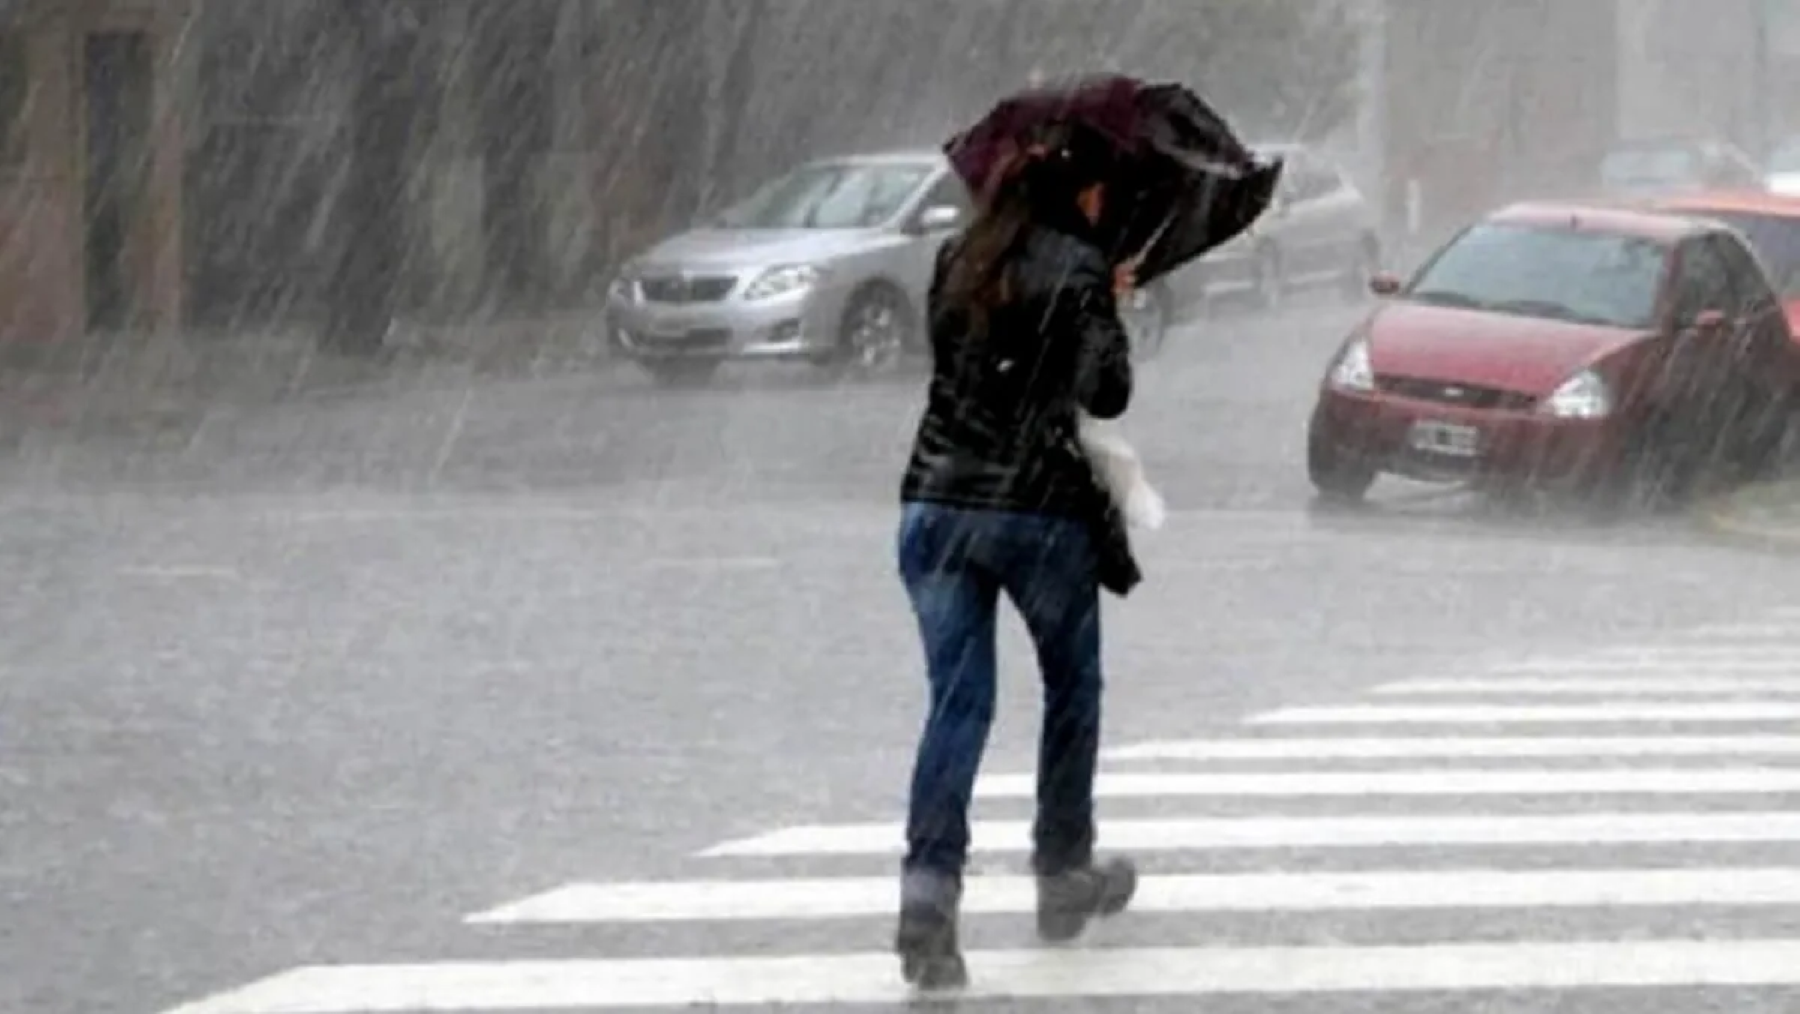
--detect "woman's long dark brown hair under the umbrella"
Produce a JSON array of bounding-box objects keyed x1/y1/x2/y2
[{"x1": 941, "y1": 124, "x2": 1111, "y2": 335}]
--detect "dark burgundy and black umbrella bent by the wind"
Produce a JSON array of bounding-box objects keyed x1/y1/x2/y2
[{"x1": 945, "y1": 74, "x2": 1282, "y2": 283}]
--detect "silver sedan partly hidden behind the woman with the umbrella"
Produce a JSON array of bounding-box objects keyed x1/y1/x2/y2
[{"x1": 607, "y1": 151, "x2": 1168, "y2": 382}]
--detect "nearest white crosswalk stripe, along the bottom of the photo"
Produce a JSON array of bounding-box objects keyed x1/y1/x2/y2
[{"x1": 151, "y1": 940, "x2": 1800, "y2": 1014}]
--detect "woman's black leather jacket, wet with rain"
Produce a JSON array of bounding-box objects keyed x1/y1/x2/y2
[{"x1": 900, "y1": 225, "x2": 1132, "y2": 521}]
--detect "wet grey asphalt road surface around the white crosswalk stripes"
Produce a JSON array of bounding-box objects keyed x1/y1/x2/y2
[{"x1": 10, "y1": 289, "x2": 1800, "y2": 1014}]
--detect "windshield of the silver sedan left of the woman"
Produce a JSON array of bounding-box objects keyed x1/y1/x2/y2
[{"x1": 715, "y1": 162, "x2": 932, "y2": 229}]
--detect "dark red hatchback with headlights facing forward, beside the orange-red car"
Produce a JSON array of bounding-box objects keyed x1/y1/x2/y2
[{"x1": 1307, "y1": 204, "x2": 1800, "y2": 499}]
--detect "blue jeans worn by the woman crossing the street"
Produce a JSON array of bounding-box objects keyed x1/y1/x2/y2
[{"x1": 898, "y1": 502, "x2": 1102, "y2": 877}]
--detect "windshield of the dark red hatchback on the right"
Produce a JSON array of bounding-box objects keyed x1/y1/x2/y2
[{"x1": 1406, "y1": 222, "x2": 1669, "y2": 330}]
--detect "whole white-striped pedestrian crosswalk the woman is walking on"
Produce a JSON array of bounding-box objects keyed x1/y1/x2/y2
[{"x1": 164, "y1": 611, "x2": 1800, "y2": 1014}]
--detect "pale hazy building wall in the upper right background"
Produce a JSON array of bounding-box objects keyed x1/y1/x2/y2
[{"x1": 1370, "y1": 0, "x2": 1800, "y2": 255}]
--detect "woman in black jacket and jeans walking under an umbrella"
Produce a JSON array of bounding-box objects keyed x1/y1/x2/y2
[{"x1": 896, "y1": 120, "x2": 1138, "y2": 989}]
